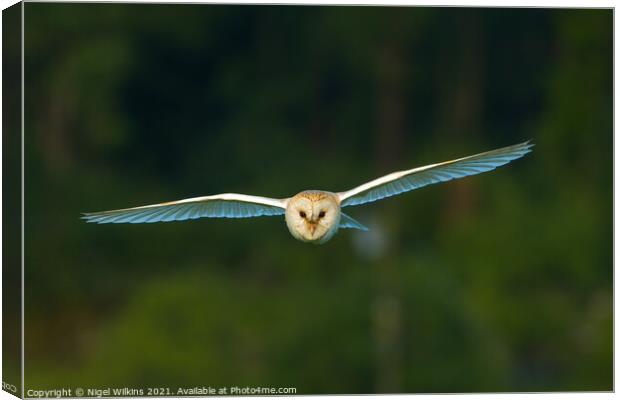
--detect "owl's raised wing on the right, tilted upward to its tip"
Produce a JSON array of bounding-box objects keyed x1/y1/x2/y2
[{"x1": 338, "y1": 141, "x2": 534, "y2": 207}]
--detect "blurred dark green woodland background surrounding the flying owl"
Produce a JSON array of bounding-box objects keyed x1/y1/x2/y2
[{"x1": 19, "y1": 3, "x2": 613, "y2": 394}]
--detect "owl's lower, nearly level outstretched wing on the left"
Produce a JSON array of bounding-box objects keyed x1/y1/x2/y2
[{"x1": 82, "y1": 193, "x2": 286, "y2": 224}]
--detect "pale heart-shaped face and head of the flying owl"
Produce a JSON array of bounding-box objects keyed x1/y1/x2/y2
[{"x1": 286, "y1": 191, "x2": 340, "y2": 244}]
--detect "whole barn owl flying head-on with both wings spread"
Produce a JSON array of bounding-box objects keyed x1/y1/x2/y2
[{"x1": 82, "y1": 142, "x2": 533, "y2": 244}]
